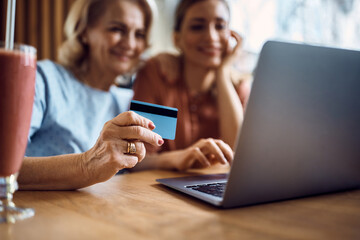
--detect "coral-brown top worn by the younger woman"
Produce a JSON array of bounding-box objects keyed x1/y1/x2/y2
[{"x1": 133, "y1": 54, "x2": 250, "y2": 152}]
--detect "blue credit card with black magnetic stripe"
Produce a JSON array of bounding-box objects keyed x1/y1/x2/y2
[{"x1": 130, "y1": 100, "x2": 178, "y2": 140}]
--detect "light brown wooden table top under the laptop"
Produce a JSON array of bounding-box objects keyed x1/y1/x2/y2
[{"x1": 0, "y1": 171, "x2": 360, "y2": 240}]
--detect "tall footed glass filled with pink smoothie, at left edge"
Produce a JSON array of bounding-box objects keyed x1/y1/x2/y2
[{"x1": 0, "y1": 42, "x2": 36, "y2": 222}]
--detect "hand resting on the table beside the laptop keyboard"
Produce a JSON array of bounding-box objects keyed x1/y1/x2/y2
[{"x1": 172, "y1": 138, "x2": 234, "y2": 171}]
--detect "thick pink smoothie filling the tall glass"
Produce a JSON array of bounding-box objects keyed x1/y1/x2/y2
[{"x1": 0, "y1": 48, "x2": 36, "y2": 176}]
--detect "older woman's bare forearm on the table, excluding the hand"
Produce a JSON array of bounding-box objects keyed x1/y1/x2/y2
[{"x1": 18, "y1": 154, "x2": 91, "y2": 190}]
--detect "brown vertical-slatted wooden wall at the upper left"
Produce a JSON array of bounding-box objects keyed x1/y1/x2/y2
[{"x1": 0, "y1": 0, "x2": 75, "y2": 60}]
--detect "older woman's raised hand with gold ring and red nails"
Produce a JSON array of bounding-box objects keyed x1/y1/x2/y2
[{"x1": 82, "y1": 111, "x2": 164, "y2": 183}]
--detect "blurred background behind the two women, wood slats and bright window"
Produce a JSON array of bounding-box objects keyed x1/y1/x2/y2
[{"x1": 0, "y1": 0, "x2": 360, "y2": 62}]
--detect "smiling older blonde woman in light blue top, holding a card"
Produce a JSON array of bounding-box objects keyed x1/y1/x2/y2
[{"x1": 19, "y1": 0, "x2": 164, "y2": 190}]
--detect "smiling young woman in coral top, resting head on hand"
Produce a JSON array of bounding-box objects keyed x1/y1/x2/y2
[{"x1": 134, "y1": 0, "x2": 250, "y2": 170}]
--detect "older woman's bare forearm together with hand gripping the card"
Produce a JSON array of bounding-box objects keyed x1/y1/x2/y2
[{"x1": 19, "y1": 112, "x2": 164, "y2": 190}]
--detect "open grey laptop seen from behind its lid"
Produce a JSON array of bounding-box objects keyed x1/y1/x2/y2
[{"x1": 157, "y1": 41, "x2": 360, "y2": 208}]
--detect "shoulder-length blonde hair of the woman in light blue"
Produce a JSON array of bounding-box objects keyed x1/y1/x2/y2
[{"x1": 58, "y1": 0, "x2": 156, "y2": 75}]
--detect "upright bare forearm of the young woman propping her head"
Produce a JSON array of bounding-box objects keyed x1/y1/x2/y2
[{"x1": 217, "y1": 69, "x2": 243, "y2": 148}]
